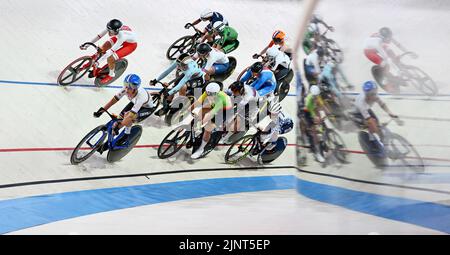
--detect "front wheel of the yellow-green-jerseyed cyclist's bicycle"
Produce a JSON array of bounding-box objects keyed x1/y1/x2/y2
[{"x1": 158, "y1": 129, "x2": 191, "y2": 159}]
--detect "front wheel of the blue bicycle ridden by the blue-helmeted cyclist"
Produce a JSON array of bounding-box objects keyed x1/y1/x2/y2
[{"x1": 70, "y1": 125, "x2": 107, "y2": 165}]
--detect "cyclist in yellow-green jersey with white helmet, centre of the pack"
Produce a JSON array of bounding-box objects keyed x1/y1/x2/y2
[{"x1": 190, "y1": 82, "x2": 233, "y2": 159}]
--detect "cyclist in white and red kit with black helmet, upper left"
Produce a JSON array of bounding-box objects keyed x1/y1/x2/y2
[{"x1": 80, "y1": 19, "x2": 137, "y2": 83}]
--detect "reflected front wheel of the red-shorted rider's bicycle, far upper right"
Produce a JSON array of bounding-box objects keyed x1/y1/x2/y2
[{"x1": 405, "y1": 66, "x2": 438, "y2": 96}]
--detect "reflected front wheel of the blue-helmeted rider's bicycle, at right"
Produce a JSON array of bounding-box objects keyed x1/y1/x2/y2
[{"x1": 386, "y1": 134, "x2": 425, "y2": 172}]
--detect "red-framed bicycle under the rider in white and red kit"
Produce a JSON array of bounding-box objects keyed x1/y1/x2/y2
[{"x1": 57, "y1": 42, "x2": 128, "y2": 86}]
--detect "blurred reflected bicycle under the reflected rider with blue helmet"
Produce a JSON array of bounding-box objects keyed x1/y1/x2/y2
[{"x1": 352, "y1": 114, "x2": 425, "y2": 172}]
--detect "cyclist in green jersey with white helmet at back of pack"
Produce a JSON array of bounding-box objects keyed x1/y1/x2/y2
[{"x1": 212, "y1": 21, "x2": 239, "y2": 54}]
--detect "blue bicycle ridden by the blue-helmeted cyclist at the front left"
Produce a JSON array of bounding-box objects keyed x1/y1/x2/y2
[{"x1": 70, "y1": 110, "x2": 149, "y2": 165}]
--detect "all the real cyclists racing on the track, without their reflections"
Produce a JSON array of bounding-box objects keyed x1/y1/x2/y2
[{"x1": 81, "y1": 10, "x2": 293, "y2": 159}]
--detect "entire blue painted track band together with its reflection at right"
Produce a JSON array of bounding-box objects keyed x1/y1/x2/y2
[{"x1": 0, "y1": 176, "x2": 450, "y2": 234}]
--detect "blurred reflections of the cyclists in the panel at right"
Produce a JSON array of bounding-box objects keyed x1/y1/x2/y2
[{"x1": 300, "y1": 15, "x2": 405, "y2": 163}]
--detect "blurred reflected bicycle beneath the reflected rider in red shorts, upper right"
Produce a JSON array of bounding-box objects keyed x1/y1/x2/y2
[{"x1": 371, "y1": 51, "x2": 438, "y2": 96}]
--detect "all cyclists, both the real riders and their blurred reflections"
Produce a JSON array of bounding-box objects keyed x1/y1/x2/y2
[{"x1": 79, "y1": 10, "x2": 403, "y2": 162}]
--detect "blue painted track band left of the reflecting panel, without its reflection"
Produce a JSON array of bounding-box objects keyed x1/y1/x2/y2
[{"x1": 0, "y1": 176, "x2": 295, "y2": 234}]
